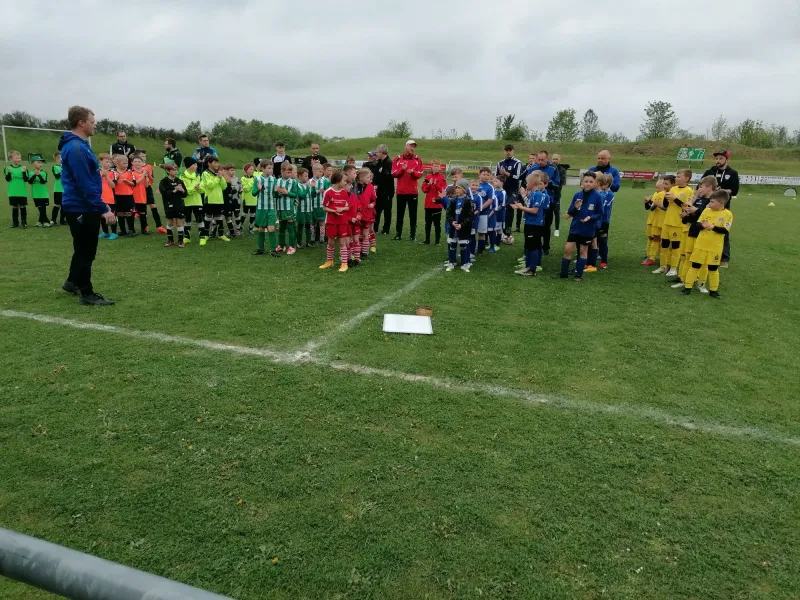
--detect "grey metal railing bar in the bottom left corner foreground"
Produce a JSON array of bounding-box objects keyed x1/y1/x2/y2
[{"x1": 0, "y1": 528, "x2": 231, "y2": 600}]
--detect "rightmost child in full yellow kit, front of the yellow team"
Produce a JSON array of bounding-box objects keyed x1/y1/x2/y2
[{"x1": 681, "y1": 190, "x2": 733, "y2": 300}]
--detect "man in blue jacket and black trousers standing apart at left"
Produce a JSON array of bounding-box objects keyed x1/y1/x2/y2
[{"x1": 58, "y1": 106, "x2": 116, "y2": 306}]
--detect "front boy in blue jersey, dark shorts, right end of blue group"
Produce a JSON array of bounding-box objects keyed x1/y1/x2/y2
[{"x1": 553, "y1": 171, "x2": 603, "y2": 281}]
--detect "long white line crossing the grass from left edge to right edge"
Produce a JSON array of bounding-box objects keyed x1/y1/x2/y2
[{"x1": 0, "y1": 310, "x2": 800, "y2": 446}]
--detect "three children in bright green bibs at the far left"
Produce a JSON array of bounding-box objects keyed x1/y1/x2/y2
[{"x1": 3, "y1": 150, "x2": 66, "y2": 229}]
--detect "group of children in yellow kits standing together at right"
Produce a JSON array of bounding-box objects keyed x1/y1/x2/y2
[{"x1": 642, "y1": 169, "x2": 733, "y2": 299}]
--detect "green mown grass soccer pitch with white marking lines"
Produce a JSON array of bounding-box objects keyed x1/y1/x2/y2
[{"x1": 0, "y1": 188, "x2": 800, "y2": 600}]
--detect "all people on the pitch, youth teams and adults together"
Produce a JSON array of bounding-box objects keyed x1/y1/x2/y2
[{"x1": 5, "y1": 107, "x2": 733, "y2": 304}]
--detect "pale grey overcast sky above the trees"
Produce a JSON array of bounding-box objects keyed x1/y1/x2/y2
[{"x1": 0, "y1": 0, "x2": 800, "y2": 138}]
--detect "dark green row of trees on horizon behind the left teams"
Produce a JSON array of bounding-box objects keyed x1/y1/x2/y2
[{"x1": 0, "y1": 111, "x2": 328, "y2": 150}]
